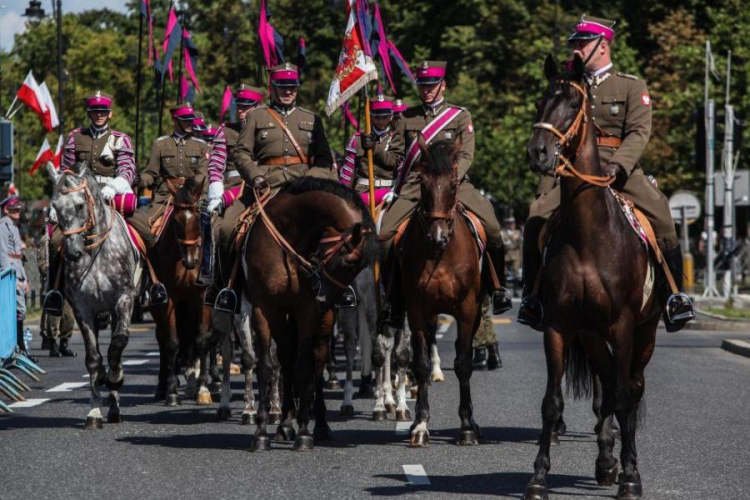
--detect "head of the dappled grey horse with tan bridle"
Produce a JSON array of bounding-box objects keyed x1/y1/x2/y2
[{"x1": 50, "y1": 164, "x2": 101, "y2": 262}]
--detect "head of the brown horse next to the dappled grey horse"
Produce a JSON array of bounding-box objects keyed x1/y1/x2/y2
[{"x1": 172, "y1": 178, "x2": 205, "y2": 269}]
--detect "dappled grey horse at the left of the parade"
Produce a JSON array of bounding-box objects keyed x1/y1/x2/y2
[{"x1": 49, "y1": 163, "x2": 145, "y2": 429}]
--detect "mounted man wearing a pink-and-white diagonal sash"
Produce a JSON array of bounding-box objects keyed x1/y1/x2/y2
[{"x1": 380, "y1": 61, "x2": 511, "y2": 328}]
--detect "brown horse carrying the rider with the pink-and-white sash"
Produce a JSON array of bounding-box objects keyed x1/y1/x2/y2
[{"x1": 397, "y1": 135, "x2": 485, "y2": 447}]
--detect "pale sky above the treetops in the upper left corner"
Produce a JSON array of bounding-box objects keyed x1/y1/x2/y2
[{"x1": 0, "y1": 0, "x2": 127, "y2": 51}]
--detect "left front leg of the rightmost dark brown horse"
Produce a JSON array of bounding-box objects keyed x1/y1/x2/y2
[{"x1": 524, "y1": 327, "x2": 565, "y2": 500}]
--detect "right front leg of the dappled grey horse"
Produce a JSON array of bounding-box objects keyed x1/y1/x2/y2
[{"x1": 106, "y1": 293, "x2": 134, "y2": 424}]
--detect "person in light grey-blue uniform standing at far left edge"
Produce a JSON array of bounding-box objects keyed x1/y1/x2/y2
[{"x1": 0, "y1": 195, "x2": 36, "y2": 361}]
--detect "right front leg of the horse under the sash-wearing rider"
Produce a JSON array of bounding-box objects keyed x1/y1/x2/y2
[{"x1": 458, "y1": 300, "x2": 482, "y2": 446}]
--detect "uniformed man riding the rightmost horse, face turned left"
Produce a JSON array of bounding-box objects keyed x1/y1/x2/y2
[{"x1": 518, "y1": 15, "x2": 695, "y2": 331}]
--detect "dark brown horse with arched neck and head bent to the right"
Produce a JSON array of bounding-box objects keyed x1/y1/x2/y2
[{"x1": 242, "y1": 177, "x2": 378, "y2": 451}]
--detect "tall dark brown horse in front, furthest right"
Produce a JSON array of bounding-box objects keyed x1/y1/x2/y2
[{"x1": 525, "y1": 56, "x2": 659, "y2": 500}]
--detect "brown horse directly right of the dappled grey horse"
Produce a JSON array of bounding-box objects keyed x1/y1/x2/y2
[{"x1": 149, "y1": 179, "x2": 211, "y2": 406}]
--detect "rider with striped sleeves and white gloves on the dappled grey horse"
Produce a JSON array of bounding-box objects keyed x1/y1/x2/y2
[{"x1": 43, "y1": 91, "x2": 136, "y2": 320}]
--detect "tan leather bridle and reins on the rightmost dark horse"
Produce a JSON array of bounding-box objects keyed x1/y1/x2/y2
[{"x1": 533, "y1": 80, "x2": 616, "y2": 187}]
